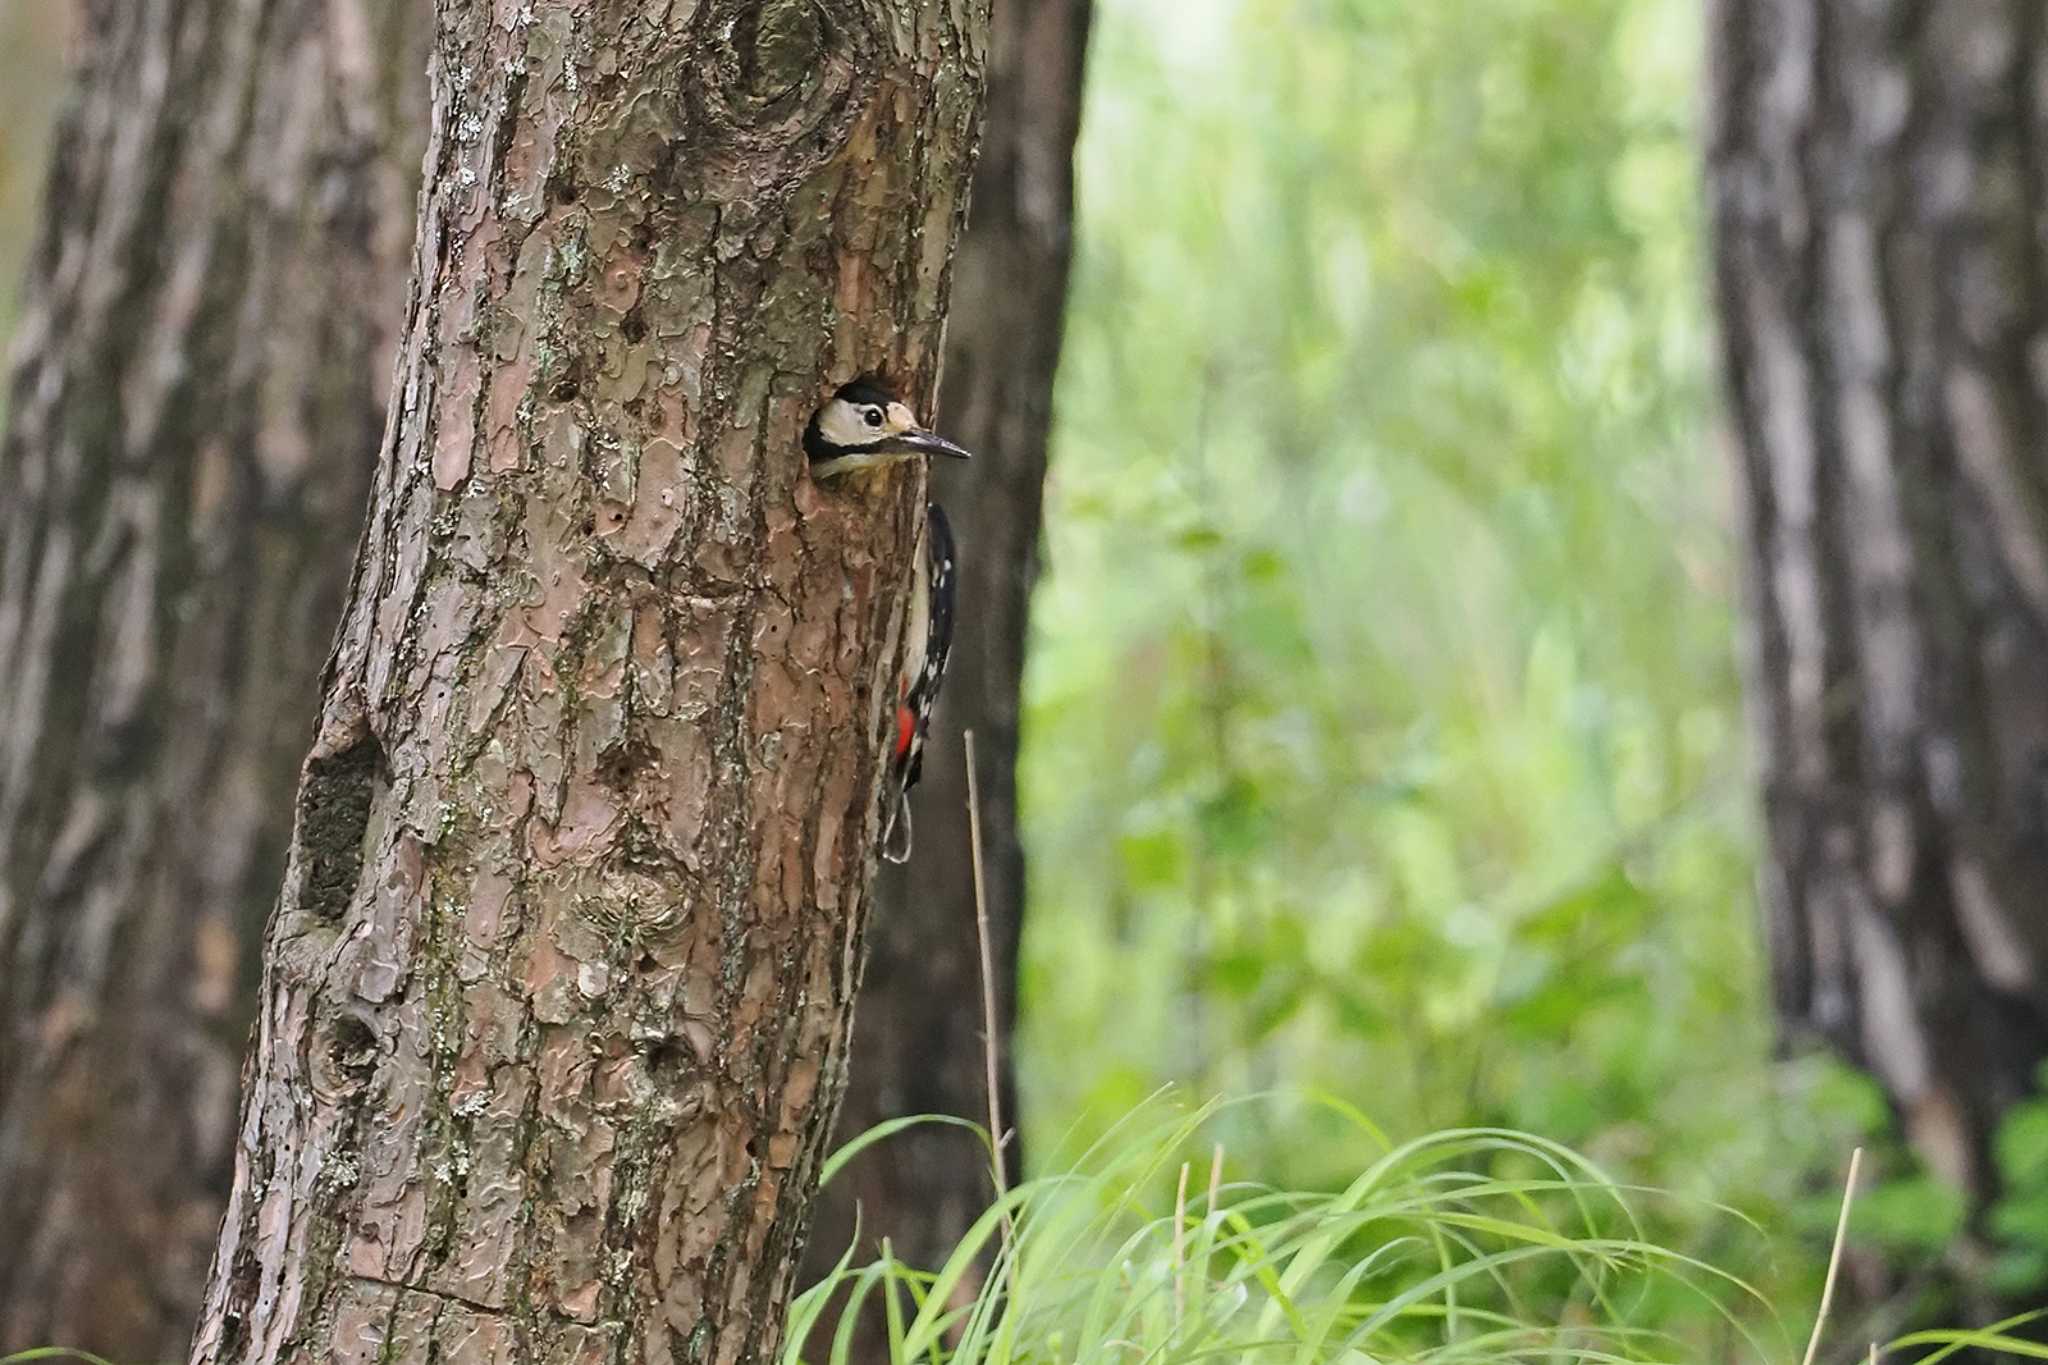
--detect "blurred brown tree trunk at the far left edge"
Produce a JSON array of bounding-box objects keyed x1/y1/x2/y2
[{"x1": 0, "y1": 0, "x2": 428, "y2": 1359}]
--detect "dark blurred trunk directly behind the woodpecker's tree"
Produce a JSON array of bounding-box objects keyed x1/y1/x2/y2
[{"x1": 811, "y1": 0, "x2": 1090, "y2": 1275}]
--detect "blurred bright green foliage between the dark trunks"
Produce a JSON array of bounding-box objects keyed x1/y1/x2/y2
[{"x1": 1020, "y1": 0, "x2": 1875, "y2": 1342}]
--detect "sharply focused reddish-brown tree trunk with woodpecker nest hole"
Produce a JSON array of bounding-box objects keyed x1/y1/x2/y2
[{"x1": 193, "y1": 0, "x2": 987, "y2": 1365}]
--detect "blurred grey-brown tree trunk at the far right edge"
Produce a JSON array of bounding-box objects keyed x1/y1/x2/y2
[{"x1": 1710, "y1": 0, "x2": 2048, "y2": 1199}]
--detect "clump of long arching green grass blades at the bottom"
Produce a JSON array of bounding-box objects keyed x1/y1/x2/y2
[{"x1": 782, "y1": 1097, "x2": 1792, "y2": 1365}]
